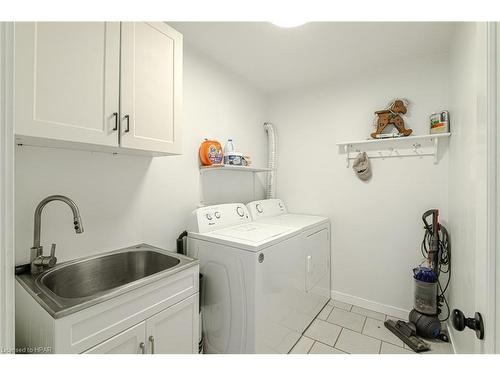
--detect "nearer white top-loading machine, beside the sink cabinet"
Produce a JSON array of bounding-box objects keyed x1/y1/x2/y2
[{"x1": 187, "y1": 203, "x2": 314, "y2": 353}]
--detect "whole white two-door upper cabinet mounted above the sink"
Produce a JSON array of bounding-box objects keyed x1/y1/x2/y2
[{"x1": 13, "y1": 22, "x2": 183, "y2": 156}]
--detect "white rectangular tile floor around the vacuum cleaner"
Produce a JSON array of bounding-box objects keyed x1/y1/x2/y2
[{"x1": 290, "y1": 300, "x2": 453, "y2": 354}]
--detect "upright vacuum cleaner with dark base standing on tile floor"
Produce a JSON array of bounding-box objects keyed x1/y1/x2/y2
[{"x1": 385, "y1": 209, "x2": 451, "y2": 352}]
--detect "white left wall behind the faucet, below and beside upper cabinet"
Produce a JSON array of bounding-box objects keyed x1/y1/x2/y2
[{"x1": 15, "y1": 45, "x2": 266, "y2": 264}]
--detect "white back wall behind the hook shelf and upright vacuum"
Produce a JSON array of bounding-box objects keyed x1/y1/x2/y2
[{"x1": 269, "y1": 54, "x2": 449, "y2": 316}]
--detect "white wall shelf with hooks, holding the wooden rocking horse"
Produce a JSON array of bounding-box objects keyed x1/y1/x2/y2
[{"x1": 337, "y1": 133, "x2": 451, "y2": 168}]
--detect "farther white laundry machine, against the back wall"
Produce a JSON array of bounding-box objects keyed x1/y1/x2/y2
[{"x1": 247, "y1": 199, "x2": 331, "y2": 314}]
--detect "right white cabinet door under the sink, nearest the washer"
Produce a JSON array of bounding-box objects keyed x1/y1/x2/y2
[{"x1": 146, "y1": 293, "x2": 199, "y2": 354}]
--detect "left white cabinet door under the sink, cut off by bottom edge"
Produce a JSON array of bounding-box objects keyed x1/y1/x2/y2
[{"x1": 84, "y1": 322, "x2": 146, "y2": 354}]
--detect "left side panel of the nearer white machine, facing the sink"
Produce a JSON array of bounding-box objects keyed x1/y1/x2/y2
[{"x1": 188, "y1": 237, "x2": 250, "y2": 354}]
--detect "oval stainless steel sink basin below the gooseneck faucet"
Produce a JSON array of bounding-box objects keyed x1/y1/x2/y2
[{"x1": 40, "y1": 250, "x2": 180, "y2": 298}]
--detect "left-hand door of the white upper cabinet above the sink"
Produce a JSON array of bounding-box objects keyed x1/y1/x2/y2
[{"x1": 14, "y1": 22, "x2": 120, "y2": 146}]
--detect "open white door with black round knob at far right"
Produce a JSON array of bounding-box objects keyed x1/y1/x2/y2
[{"x1": 449, "y1": 23, "x2": 494, "y2": 353}]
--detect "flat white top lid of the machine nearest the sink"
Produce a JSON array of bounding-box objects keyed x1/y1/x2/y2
[{"x1": 188, "y1": 222, "x2": 299, "y2": 252}]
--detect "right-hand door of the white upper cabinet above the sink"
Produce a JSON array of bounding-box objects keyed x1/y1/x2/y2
[{"x1": 120, "y1": 22, "x2": 182, "y2": 154}]
